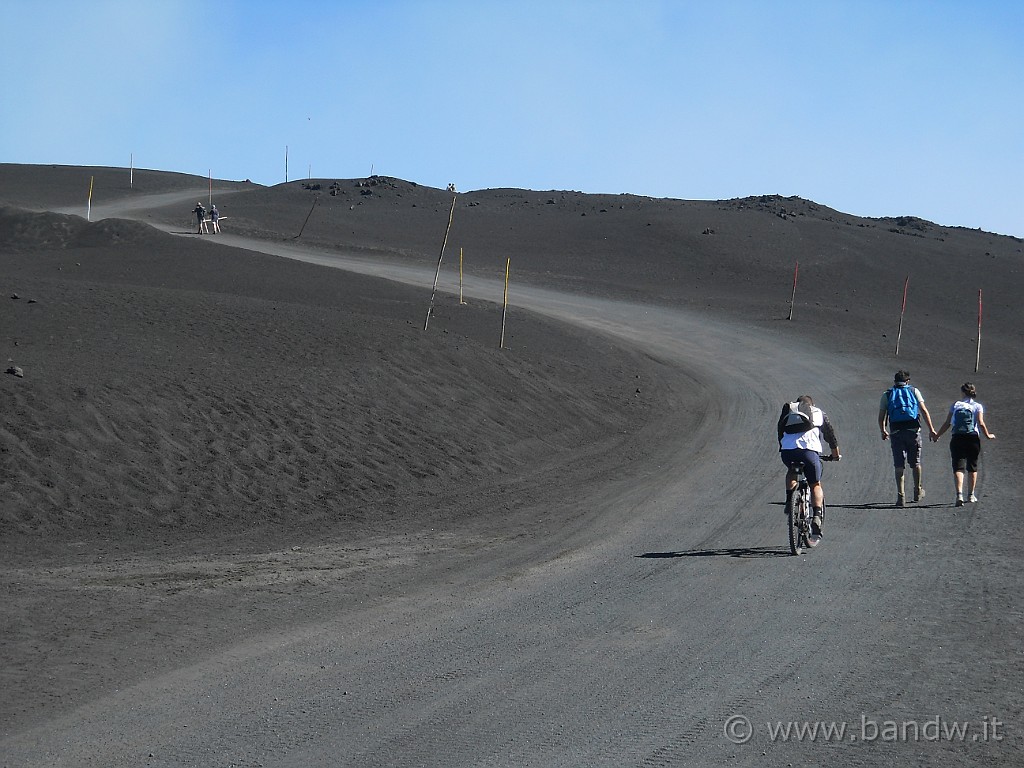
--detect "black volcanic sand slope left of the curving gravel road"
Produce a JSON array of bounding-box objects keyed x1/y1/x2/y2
[{"x1": 0, "y1": 169, "x2": 675, "y2": 728}]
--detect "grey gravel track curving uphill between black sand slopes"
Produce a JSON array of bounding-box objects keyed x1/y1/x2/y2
[{"x1": 8, "y1": 193, "x2": 1020, "y2": 768}]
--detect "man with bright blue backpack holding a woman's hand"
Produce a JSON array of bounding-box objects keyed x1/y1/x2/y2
[{"x1": 879, "y1": 370, "x2": 935, "y2": 507}]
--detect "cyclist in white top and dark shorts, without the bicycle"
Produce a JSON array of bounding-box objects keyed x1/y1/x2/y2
[{"x1": 778, "y1": 394, "x2": 841, "y2": 540}]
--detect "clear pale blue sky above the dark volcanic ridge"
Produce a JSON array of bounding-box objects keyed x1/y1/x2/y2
[{"x1": 0, "y1": 0, "x2": 1024, "y2": 237}]
